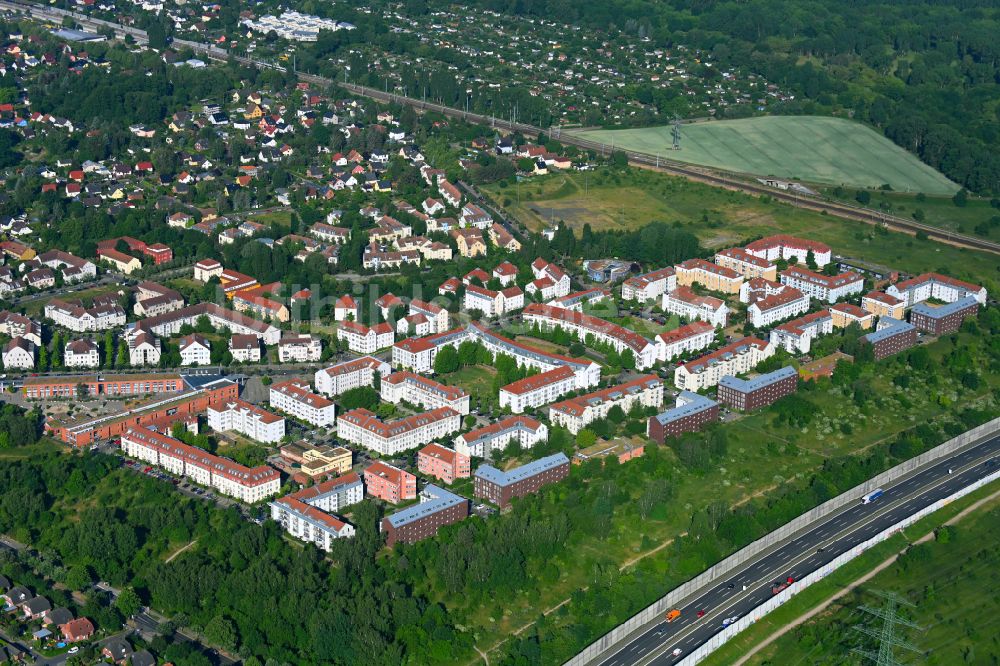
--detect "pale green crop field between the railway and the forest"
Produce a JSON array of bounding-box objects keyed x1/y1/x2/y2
[{"x1": 578, "y1": 116, "x2": 958, "y2": 195}]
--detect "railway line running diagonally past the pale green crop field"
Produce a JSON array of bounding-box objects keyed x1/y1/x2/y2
[{"x1": 0, "y1": 0, "x2": 1000, "y2": 254}]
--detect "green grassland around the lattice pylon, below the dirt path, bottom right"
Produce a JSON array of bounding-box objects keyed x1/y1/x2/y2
[{"x1": 746, "y1": 488, "x2": 1000, "y2": 666}]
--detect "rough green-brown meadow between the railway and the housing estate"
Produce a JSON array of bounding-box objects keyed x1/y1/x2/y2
[{"x1": 484, "y1": 168, "x2": 1000, "y2": 287}]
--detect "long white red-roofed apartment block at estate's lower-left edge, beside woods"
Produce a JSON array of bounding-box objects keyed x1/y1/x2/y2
[{"x1": 121, "y1": 426, "x2": 281, "y2": 504}]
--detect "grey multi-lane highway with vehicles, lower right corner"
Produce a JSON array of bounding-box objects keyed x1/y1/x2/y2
[{"x1": 598, "y1": 436, "x2": 1000, "y2": 666}]
